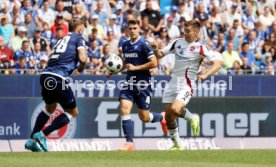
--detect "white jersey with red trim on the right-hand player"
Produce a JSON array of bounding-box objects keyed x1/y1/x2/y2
[{"x1": 162, "y1": 38, "x2": 219, "y2": 80}]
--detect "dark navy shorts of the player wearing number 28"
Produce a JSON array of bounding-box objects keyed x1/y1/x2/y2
[{"x1": 40, "y1": 74, "x2": 76, "y2": 109}]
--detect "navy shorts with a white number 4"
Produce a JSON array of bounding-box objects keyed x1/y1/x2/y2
[{"x1": 119, "y1": 85, "x2": 152, "y2": 110}]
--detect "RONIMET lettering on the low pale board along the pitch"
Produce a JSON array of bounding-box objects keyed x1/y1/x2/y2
[{"x1": 47, "y1": 140, "x2": 111, "y2": 151}]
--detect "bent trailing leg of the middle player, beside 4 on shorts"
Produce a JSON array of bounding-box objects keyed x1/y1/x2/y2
[{"x1": 135, "y1": 88, "x2": 168, "y2": 135}]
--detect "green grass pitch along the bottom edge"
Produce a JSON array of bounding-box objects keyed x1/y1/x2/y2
[{"x1": 0, "y1": 150, "x2": 276, "y2": 167}]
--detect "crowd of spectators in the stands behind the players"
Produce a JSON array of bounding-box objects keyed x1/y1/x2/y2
[{"x1": 0, "y1": 0, "x2": 276, "y2": 75}]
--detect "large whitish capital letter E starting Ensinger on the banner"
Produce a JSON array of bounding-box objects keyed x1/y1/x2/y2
[{"x1": 95, "y1": 102, "x2": 119, "y2": 137}]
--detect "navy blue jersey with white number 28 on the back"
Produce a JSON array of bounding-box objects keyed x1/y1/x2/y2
[{"x1": 43, "y1": 33, "x2": 85, "y2": 77}]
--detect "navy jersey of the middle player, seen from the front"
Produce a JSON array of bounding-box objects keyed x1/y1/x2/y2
[{"x1": 122, "y1": 37, "x2": 154, "y2": 83}]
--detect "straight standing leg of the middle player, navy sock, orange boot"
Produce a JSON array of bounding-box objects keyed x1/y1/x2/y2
[{"x1": 119, "y1": 98, "x2": 135, "y2": 151}]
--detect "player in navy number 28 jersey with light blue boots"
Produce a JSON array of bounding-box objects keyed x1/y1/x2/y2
[{"x1": 25, "y1": 19, "x2": 87, "y2": 152}]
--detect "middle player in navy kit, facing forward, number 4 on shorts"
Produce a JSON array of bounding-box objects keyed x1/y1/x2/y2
[{"x1": 106, "y1": 20, "x2": 167, "y2": 151}]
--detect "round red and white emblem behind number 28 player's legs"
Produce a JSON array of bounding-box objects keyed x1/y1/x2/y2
[{"x1": 31, "y1": 102, "x2": 77, "y2": 139}]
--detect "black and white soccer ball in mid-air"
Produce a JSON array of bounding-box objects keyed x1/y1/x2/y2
[{"x1": 105, "y1": 55, "x2": 123, "y2": 73}]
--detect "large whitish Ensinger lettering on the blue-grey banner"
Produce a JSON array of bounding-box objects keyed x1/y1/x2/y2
[{"x1": 95, "y1": 101, "x2": 269, "y2": 137}]
